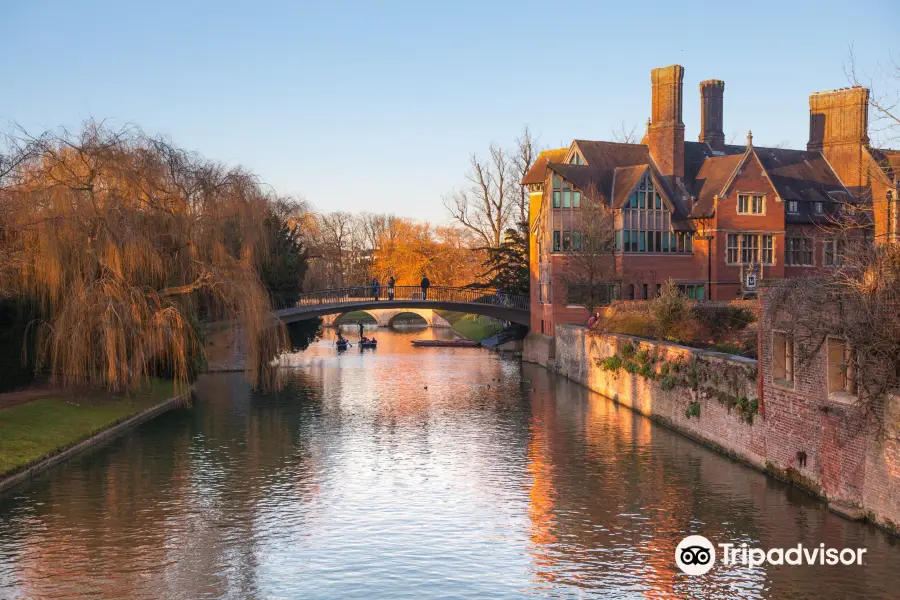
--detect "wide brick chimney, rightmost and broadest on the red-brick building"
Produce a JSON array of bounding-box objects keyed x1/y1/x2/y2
[{"x1": 806, "y1": 86, "x2": 869, "y2": 193}]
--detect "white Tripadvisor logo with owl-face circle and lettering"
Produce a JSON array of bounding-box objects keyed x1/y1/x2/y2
[{"x1": 675, "y1": 535, "x2": 867, "y2": 575}]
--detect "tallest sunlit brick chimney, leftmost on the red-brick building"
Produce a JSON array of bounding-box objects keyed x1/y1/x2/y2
[{"x1": 649, "y1": 65, "x2": 684, "y2": 180}]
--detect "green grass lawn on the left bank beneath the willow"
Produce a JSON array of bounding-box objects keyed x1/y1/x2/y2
[{"x1": 0, "y1": 380, "x2": 175, "y2": 477}]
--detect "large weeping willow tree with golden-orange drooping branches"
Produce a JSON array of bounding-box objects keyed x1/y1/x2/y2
[{"x1": 0, "y1": 123, "x2": 285, "y2": 391}]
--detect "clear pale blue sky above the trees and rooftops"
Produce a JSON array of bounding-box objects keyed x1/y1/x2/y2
[{"x1": 0, "y1": 0, "x2": 900, "y2": 222}]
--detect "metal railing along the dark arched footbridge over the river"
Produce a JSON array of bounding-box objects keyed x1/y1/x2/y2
[{"x1": 278, "y1": 285, "x2": 529, "y2": 310}]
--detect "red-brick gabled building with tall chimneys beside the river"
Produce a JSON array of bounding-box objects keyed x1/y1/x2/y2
[{"x1": 522, "y1": 65, "x2": 900, "y2": 334}]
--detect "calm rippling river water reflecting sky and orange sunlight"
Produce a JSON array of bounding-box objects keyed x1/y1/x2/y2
[{"x1": 0, "y1": 330, "x2": 900, "y2": 599}]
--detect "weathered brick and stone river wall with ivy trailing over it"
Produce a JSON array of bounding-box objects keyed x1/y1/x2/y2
[{"x1": 523, "y1": 325, "x2": 900, "y2": 530}]
